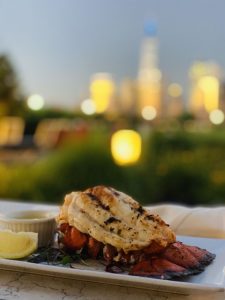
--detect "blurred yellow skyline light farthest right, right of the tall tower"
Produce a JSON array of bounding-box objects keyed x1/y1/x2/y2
[{"x1": 198, "y1": 76, "x2": 219, "y2": 112}]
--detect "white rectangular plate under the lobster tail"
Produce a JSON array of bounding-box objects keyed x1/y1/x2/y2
[{"x1": 0, "y1": 236, "x2": 225, "y2": 295}]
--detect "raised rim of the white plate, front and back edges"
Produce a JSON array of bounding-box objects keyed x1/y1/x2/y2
[{"x1": 0, "y1": 236, "x2": 225, "y2": 295}]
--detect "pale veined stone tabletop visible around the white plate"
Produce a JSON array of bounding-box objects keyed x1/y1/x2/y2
[{"x1": 0, "y1": 200, "x2": 225, "y2": 300}]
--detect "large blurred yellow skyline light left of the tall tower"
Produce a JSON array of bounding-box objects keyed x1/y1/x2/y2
[{"x1": 90, "y1": 74, "x2": 114, "y2": 113}]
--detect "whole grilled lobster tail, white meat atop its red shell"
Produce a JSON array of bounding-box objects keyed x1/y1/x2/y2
[{"x1": 57, "y1": 186, "x2": 215, "y2": 279}]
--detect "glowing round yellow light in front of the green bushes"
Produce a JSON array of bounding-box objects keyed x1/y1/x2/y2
[{"x1": 111, "y1": 130, "x2": 141, "y2": 165}]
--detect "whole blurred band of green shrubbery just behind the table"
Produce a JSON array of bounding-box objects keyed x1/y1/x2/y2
[{"x1": 0, "y1": 131, "x2": 225, "y2": 205}]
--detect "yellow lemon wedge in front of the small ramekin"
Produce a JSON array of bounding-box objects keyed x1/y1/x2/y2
[{"x1": 0, "y1": 230, "x2": 38, "y2": 259}]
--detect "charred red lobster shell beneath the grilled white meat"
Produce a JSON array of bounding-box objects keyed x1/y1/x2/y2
[{"x1": 59, "y1": 223, "x2": 215, "y2": 279}]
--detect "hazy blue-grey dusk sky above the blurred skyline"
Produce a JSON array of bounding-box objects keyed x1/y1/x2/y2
[{"x1": 0, "y1": 0, "x2": 225, "y2": 107}]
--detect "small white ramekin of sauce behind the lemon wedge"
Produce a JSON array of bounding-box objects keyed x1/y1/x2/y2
[{"x1": 0, "y1": 210, "x2": 57, "y2": 247}]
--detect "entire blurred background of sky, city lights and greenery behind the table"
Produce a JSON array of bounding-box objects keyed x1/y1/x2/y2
[{"x1": 0, "y1": 0, "x2": 225, "y2": 205}]
